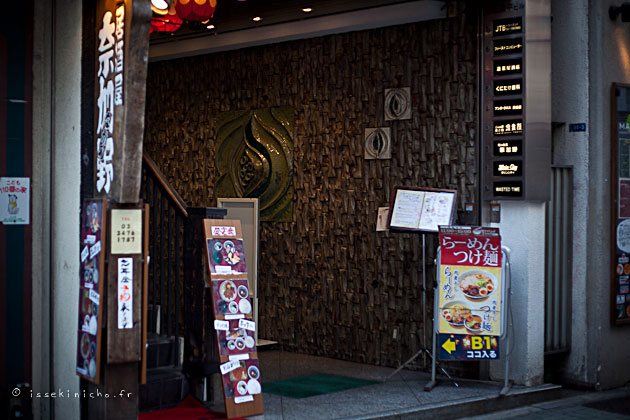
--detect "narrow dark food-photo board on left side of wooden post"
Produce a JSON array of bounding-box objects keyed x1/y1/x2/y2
[{"x1": 76, "y1": 199, "x2": 107, "y2": 383}]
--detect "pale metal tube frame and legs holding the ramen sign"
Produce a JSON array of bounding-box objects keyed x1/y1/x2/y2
[{"x1": 424, "y1": 246, "x2": 512, "y2": 397}]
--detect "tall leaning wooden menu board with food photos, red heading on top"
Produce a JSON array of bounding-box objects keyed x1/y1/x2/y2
[{"x1": 203, "y1": 219, "x2": 264, "y2": 418}]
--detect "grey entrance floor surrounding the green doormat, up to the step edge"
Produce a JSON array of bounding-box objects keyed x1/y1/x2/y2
[{"x1": 232, "y1": 351, "x2": 592, "y2": 420}]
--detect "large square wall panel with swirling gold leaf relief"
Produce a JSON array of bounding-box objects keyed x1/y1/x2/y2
[{"x1": 215, "y1": 107, "x2": 295, "y2": 222}]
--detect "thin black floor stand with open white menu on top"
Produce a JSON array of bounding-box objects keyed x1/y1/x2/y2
[{"x1": 387, "y1": 186, "x2": 457, "y2": 372}]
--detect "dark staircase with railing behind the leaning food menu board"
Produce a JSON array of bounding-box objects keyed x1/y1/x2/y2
[{"x1": 140, "y1": 154, "x2": 226, "y2": 412}]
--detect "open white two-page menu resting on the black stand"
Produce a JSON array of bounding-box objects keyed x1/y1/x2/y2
[{"x1": 387, "y1": 187, "x2": 457, "y2": 232}]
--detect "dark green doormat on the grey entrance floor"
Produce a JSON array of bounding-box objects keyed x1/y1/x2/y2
[{"x1": 262, "y1": 373, "x2": 379, "y2": 398}]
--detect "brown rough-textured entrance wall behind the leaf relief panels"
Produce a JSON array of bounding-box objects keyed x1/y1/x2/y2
[{"x1": 145, "y1": 8, "x2": 478, "y2": 366}]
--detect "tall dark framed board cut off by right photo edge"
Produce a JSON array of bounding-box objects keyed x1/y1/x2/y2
[{"x1": 611, "y1": 84, "x2": 630, "y2": 324}]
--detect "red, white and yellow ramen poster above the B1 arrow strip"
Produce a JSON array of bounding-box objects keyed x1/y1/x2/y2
[{"x1": 436, "y1": 226, "x2": 503, "y2": 336}]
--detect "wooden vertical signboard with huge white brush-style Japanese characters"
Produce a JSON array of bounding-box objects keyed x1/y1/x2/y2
[{"x1": 94, "y1": 0, "x2": 151, "y2": 203}]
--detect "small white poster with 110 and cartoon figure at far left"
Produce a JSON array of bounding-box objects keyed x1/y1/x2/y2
[{"x1": 0, "y1": 177, "x2": 31, "y2": 225}]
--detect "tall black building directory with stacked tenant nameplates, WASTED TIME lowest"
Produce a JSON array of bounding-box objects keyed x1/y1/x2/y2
[{"x1": 482, "y1": 0, "x2": 551, "y2": 200}]
